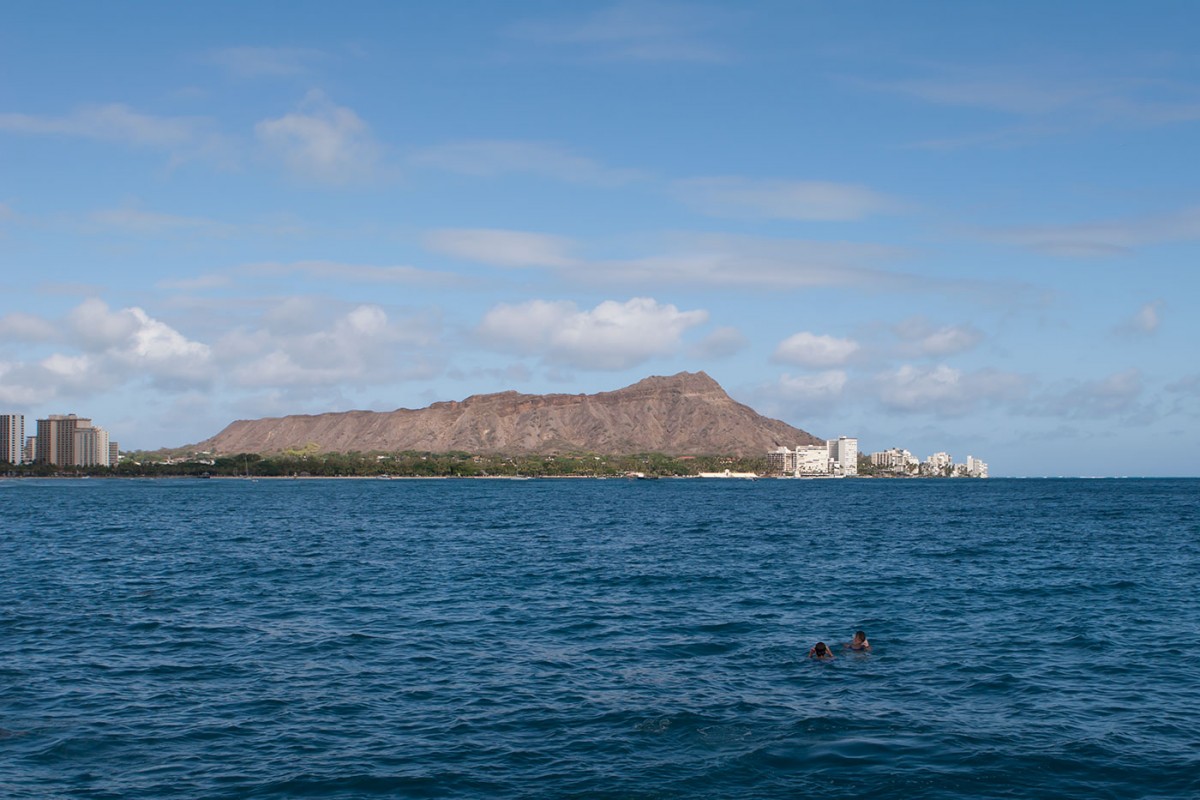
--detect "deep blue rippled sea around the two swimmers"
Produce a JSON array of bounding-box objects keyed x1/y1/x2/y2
[{"x1": 0, "y1": 479, "x2": 1200, "y2": 800}]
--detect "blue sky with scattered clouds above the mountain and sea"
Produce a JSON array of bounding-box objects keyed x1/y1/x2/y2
[{"x1": 0, "y1": 0, "x2": 1200, "y2": 475}]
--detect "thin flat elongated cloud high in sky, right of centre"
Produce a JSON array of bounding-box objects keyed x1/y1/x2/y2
[{"x1": 673, "y1": 178, "x2": 896, "y2": 222}]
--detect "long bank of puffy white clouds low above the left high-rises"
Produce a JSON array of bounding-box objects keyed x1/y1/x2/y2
[{"x1": 0, "y1": 297, "x2": 444, "y2": 419}]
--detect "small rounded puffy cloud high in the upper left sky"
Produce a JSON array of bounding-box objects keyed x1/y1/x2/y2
[{"x1": 254, "y1": 91, "x2": 380, "y2": 184}]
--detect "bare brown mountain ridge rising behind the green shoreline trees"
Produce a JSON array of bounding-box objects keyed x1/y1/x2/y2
[{"x1": 190, "y1": 372, "x2": 821, "y2": 456}]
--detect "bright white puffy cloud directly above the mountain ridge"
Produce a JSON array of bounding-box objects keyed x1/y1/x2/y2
[{"x1": 478, "y1": 297, "x2": 708, "y2": 369}]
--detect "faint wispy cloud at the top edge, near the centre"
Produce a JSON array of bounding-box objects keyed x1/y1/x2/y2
[{"x1": 508, "y1": 2, "x2": 731, "y2": 62}]
